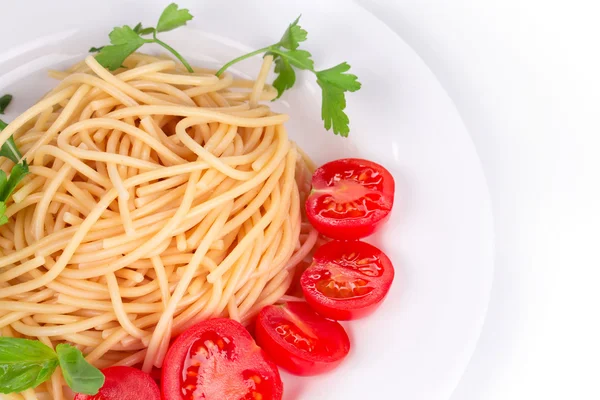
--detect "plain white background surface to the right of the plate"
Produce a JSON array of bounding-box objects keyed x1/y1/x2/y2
[{"x1": 360, "y1": 0, "x2": 600, "y2": 400}]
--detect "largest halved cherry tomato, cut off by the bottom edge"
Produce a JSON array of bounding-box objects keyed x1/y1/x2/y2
[{"x1": 161, "y1": 318, "x2": 283, "y2": 400}]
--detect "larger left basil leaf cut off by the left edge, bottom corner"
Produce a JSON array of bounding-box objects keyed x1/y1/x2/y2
[{"x1": 0, "y1": 338, "x2": 58, "y2": 394}]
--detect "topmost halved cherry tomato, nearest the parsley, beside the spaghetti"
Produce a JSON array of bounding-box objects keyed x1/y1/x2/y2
[{"x1": 306, "y1": 158, "x2": 394, "y2": 240}]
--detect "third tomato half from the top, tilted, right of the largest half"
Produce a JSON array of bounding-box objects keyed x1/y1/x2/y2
[{"x1": 256, "y1": 302, "x2": 350, "y2": 375}]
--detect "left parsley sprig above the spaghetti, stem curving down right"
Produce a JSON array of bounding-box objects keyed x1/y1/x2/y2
[{"x1": 90, "y1": 3, "x2": 194, "y2": 72}]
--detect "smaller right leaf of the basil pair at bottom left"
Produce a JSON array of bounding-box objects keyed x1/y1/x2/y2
[{"x1": 56, "y1": 344, "x2": 104, "y2": 395}]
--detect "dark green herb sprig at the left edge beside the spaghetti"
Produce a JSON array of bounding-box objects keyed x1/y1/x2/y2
[{"x1": 0, "y1": 94, "x2": 29, "y2": 225}]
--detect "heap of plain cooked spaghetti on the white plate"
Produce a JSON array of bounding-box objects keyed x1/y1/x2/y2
[{"x1": 0, "y1": 53, "x2": 318, "y2": 400}]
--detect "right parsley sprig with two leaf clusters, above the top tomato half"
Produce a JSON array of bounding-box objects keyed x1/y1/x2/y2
[{"x1": 217, "y1": 17, "x2": 361, "y2": 137}]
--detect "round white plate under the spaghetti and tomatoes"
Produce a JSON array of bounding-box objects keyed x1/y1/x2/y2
[{"x1": 0, "y1": 0, "x2": 493, "y2": 400}]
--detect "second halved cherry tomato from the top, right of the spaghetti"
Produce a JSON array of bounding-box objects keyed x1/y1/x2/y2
[{"x1": 300, "y1": 241, "x2": 394, "y2": 320}]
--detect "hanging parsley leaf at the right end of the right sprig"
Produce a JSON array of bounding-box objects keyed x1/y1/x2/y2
[{"x1": 317, "y1": 62, "x2": 361, "y2": 137}]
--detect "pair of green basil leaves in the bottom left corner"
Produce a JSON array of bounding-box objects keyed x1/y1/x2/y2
[{"x1": 0, "y1": 337, "x2": 104, "y2": 395}]
